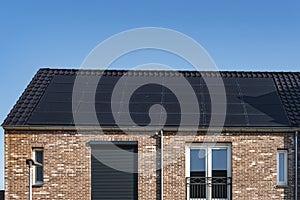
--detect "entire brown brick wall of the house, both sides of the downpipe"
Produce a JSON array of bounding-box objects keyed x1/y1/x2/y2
[{"x1": 5, "y1": 131, "x2": 294, "y2": 200}]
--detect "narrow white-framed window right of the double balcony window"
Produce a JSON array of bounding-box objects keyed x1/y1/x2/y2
[{"x1": 277, "y1": 150, "x2": 287, "y2": 185}]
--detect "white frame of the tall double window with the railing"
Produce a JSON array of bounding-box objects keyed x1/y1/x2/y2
[{"x1": 185, "y1": 143, "x2": 232, "y2": 200}]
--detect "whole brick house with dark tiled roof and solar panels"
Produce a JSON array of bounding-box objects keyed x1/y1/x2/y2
[{"x1": 2, "y1": 69, "x2": 300, "y2": 200}]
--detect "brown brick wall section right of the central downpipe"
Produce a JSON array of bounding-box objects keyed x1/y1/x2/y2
[{"x1": 164, "y1": 133, "x2": 295, "y2": 200}]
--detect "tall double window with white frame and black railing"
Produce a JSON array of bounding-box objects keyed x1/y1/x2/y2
[{"x1": 186, "y1": 144, "x2": 231, "y2": 200}]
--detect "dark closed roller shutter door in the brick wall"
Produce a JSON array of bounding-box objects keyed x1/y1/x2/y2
[{"x1": 90, "y1": 142, "x2": 138, "y2": 200}]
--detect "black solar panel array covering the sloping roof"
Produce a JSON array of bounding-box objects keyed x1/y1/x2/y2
[{"x1": 28, "y1": 75, "x2": 290, "y2": 127}]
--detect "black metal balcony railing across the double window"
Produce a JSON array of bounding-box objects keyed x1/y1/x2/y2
[{"x1": 186, "y1": 177, "x2": 231, "y2": 200}]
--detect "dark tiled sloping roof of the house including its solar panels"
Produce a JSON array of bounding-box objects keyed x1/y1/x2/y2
[{"x1": 2, "y1": 68, "x2": 300, "y2": 127}]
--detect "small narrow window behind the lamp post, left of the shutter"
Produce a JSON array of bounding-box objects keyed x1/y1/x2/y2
[{"x1": 32, "y1": 148, "x2": 44, "y2": 185}]
